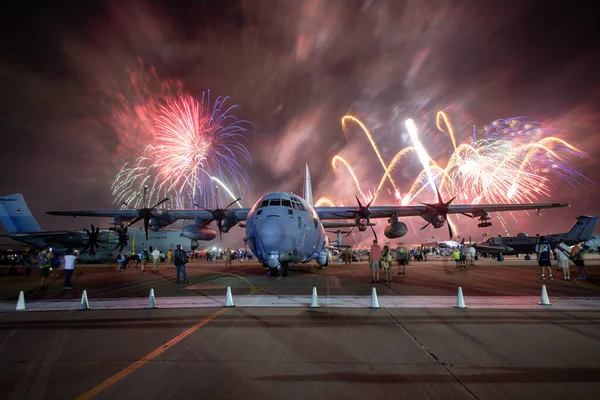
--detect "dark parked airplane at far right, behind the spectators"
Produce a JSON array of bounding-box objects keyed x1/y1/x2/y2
[{"x1": 475, "y1": 215, "x2": 600, "y2": 255}]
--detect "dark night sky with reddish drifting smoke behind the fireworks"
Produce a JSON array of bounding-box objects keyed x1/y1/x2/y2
[{"x1": 0, "y1": 0, "x2": 600, "y2": 247}]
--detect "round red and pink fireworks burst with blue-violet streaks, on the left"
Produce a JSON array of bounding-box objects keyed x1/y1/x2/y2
[{"x1": 112, "y1": 65, "x2": 252, "y2": 208}]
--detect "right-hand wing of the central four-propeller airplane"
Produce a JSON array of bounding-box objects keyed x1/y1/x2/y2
[{"x1": 315, "y1": 203, "x2": 569, "y2": 220}]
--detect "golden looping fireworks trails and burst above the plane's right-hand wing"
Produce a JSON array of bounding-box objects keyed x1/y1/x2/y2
[{"x1": 316, "y1": 112, "x2": 591, "y2": 238}]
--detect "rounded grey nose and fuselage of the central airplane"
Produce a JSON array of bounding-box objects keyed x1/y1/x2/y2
[{"x1": 246, "y1": 192, "x2": 327, "y2": 274}]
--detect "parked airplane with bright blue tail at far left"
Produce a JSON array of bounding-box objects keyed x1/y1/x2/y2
[{"x1": 0, "y1": 193, "x2": 198, "y2": 262}]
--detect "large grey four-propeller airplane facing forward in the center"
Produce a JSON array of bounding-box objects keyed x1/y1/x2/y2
[{"x1": 48, "y1": 165, "x2": 569, "y2": 276}]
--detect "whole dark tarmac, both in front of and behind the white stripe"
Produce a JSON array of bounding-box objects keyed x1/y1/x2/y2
[{"x1": 0, "y1": 258, "x2": 600, "y2": 400}]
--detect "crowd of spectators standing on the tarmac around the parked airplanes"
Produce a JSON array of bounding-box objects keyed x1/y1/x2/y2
[{"x1": 1, "y1": 236, "x2": 589, "y2": 290}]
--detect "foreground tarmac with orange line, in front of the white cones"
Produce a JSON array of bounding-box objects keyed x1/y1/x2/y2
[{"x1": 0, "y1": 308, "x2": 600, "y2": 400}]
